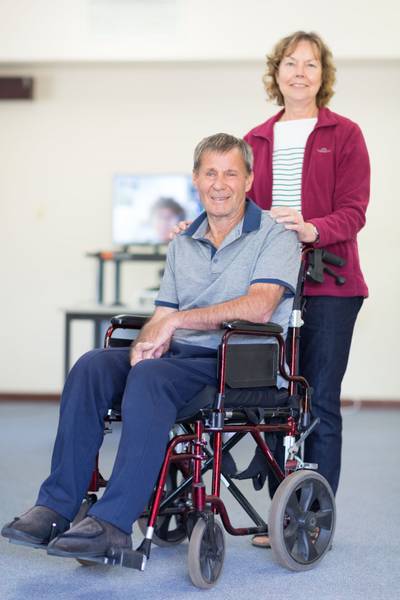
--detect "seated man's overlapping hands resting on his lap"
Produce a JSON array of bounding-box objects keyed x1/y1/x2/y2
[{"x1": 130, "y1": 311, "x2": 176, "y2": 367}]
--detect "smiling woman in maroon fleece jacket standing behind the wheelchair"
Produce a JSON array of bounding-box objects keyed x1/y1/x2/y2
[{"x1": 245, "y1": 31, "x2": 370, "y2": 547}]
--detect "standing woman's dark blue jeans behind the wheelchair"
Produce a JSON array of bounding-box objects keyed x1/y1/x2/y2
[{"x1": 300, "y1": 296, "x2": 363, "y2": 494}]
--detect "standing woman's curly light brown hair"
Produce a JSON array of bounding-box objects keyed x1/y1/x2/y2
[{"x1": 263, "y1": 31, "x2": 336, "y2": 108}]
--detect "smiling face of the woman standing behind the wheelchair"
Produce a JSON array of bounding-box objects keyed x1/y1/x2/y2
[{"x1": 276, "y1": 40, "x2": 322, "y2": 105}]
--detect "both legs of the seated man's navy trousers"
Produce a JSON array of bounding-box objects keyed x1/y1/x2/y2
[{"x1": 36, "y1": 343, "x2": 217, "y2": 534}]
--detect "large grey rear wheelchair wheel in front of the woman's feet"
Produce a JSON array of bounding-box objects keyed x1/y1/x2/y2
[{"x1": 268, "y1": 470, "x2": 336, "y2": 571}]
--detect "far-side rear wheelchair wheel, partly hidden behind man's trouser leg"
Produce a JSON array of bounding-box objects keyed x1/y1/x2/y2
[{"x1": 137, "y1": 464, "x2": 187, "y2": 547}]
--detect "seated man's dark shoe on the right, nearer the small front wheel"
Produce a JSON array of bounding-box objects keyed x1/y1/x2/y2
[{"x1": 47, "y1": 517, "x2": 132, "y2": 558}]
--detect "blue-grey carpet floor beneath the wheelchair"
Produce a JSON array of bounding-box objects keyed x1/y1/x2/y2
[{"x1": 0, "y1": 403, "x2": 400, "y2": 600}]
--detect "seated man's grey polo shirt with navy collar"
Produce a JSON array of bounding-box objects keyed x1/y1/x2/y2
[{"x1": 155, "y1": 200, "x2": 300, "y2": 372}]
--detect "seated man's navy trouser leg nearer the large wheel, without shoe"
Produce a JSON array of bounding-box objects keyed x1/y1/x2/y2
[{"x1": 89, "y1": 354, "x2": 216, "y2": 533}]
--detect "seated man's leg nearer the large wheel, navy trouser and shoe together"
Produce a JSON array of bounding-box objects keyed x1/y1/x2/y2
[{"x1": 48, "y1": 344, "x2": 216, "y2": 557}]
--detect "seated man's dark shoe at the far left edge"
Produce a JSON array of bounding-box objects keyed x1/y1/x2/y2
[{"x1": 1, "y1": 506, "x2": 69, "y2": 548}]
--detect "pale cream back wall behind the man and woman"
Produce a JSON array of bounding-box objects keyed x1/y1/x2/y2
[{"x1": 0, "y1": 61, "x2": 400, "y2": 398}]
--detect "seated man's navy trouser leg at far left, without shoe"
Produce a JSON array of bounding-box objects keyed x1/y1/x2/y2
[{"x1": 36, "y1": 348, "x2": 131, "y2": 520}]
